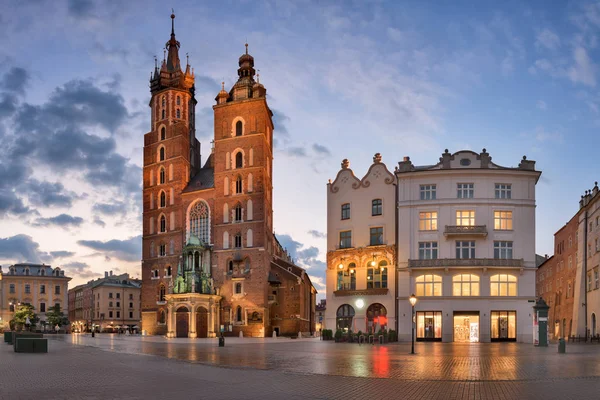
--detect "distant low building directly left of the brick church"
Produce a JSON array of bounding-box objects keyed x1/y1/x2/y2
[{"x1": 69, "y1": 271, "x2": 142, "y2": 332}]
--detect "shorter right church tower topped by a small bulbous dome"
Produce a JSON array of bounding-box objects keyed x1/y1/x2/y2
[{"x1": 213, "y1": 44, "x2": 274, "y2": 336}]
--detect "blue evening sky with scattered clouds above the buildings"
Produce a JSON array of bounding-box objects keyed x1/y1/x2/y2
[{"x1": 0, "y1": 0, "x2": 600, "y2": 297}]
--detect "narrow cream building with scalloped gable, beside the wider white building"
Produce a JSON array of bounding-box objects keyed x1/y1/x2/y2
[{"x1": 324, "y1": 153, "x2": 396, "y2": 332}]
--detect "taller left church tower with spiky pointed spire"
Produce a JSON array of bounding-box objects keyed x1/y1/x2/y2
[{"x1": 142, "y1": 14, "x2": 200, "y2": 334}]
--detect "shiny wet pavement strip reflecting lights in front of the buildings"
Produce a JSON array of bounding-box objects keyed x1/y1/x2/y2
[{"x1": 62, "y1": 334, "x2": 600, "y2": 381}]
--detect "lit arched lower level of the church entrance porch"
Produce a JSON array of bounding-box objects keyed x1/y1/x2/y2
[{"x1": 165, "y1": 293, "x2": 221, "y2": 338}]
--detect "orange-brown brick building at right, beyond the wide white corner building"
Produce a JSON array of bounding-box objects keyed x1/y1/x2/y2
[{"x1": 536, "y1": 215, "x2": 579, "y2": 339}]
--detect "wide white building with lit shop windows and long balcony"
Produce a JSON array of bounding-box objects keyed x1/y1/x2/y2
[{"x1": 396, "y1": 149, "x2": 541, "y2": 343}]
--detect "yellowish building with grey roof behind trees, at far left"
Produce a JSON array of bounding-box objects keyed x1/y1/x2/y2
[{"x1": 0, "y1": 264, "x2": 71, "y2": 329}]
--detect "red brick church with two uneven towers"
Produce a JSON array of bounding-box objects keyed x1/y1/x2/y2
[{"x1": 142, "y1": 15, "x2": 316, "y2": 338}]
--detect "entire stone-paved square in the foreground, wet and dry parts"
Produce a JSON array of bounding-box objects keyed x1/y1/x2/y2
[{"x1": 0, "y1": 335, "x2": 600, "y2": 400}]
